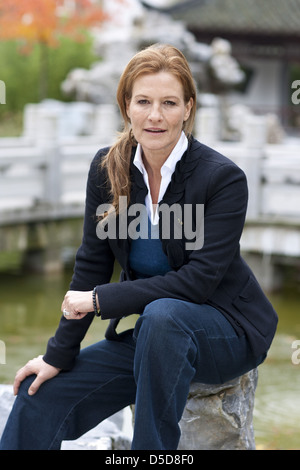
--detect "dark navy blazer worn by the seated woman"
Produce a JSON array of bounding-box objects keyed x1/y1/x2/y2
[{"x1": 44, "y1": 138, "x2": 277, "y2": 369}]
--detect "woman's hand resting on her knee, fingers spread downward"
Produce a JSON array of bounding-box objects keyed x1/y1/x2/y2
[{"x1": 14, "y1": 356, "x2": 61, "y2": 395}]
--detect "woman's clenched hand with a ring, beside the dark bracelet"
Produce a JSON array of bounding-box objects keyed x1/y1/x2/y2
[{"x1": 61, "y1": 290, "x2": 94, "y2": 320}]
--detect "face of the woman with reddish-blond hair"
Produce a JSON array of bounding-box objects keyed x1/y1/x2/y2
[{"x1": 126, "y1": 72, "x2": 193, "y2": 163}]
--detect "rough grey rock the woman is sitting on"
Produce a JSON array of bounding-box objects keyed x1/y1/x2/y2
[{"x1": 178, "y1": 369, "x2": 258, "y2": 450}]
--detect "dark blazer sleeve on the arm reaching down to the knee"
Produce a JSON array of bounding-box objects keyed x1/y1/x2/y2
[{"x1": 44, "y1": 151, "x2": 114, "y2": 370}]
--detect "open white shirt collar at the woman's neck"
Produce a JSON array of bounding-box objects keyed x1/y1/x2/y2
[{"x1": 133, "y1": 132, "x2": 188, "y2": 225}]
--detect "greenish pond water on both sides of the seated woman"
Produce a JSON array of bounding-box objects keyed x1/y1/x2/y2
[{"x1": 0, "y1": 271, "x2": 300, "y2": 450}]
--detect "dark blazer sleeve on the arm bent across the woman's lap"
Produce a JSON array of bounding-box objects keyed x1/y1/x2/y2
[{"x1": 97, "y1": 162, "x2": 248, "y2": 319}]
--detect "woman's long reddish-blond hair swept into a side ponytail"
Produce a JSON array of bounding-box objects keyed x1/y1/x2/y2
[{"x1": 102, "y1": 44, "x2": 196, "y2": 212}]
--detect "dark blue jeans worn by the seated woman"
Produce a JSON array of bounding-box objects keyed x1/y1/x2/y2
[{"x1": 0, "y1": 299, "x2": 264, "y2": 450}]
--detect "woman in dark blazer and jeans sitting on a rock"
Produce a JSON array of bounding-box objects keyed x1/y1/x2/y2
[{"x1": 2, "y1": 45, "x2": 277, "y2": 450}]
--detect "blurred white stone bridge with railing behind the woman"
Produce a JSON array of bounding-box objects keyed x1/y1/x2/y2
[{"x1": 0, "y1": 106, "x2": 300, "y2": 289}]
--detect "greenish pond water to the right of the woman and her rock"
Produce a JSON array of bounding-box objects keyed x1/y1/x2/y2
[{"x1": 254, "y1": 292, "x2": 300, "y2": 450}]
